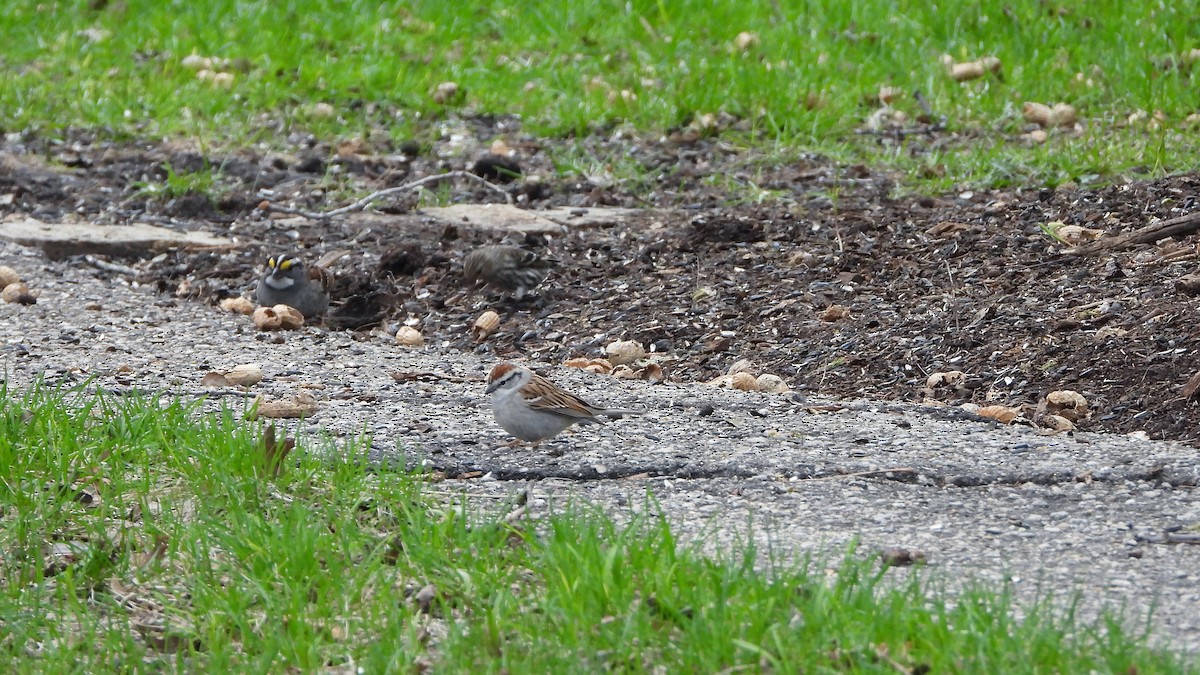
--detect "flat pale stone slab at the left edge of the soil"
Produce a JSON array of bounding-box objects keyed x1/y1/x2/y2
[{"x1": 0, "y1": 219, "x2": 235, "y2": 259}]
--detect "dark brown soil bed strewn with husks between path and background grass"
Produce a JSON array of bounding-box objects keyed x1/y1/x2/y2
[{"x1": 0, "y1": 120, "x2": 1200, "y2": 443}]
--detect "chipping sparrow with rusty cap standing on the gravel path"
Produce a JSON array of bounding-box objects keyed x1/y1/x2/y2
[{"x1": 486, "y1": 363, "x2": 641, "y2": 444}]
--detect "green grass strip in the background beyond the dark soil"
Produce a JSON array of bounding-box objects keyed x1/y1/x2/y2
[{"x1": 0, "y1": 0, "x2": 1200, "y2": 187}]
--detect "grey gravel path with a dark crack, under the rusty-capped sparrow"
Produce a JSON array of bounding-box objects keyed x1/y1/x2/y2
[{"x1": 0, "y1": 245, "x2": 1200, "y2": 651}]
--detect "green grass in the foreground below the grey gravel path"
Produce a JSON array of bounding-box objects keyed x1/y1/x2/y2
[{"x1": 0, "y1": 387, "x2": 1184, "y2": 674}]
